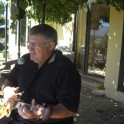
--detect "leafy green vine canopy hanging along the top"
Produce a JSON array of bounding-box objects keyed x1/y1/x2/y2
[{"x1": 10, "y1": 0, "x2": 124, "y2": 25}]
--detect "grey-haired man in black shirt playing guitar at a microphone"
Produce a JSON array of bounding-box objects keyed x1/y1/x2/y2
[{"x1": 2, "y1": 24, "x2": 81, "y2": 124}]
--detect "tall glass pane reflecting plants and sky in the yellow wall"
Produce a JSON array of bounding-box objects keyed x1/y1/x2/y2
[{"x1": 88, "y1": 4, "x2": 109, "y2": 76}]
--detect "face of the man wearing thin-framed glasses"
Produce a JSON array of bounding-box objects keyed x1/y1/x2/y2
[{"x1": 28, "y1": 34, "x2": 54, "y2": 64}]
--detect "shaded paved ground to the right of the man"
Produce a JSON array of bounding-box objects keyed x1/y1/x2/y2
[{"x1": 75, "y1": 78, "x2": 124, "y2": 124}]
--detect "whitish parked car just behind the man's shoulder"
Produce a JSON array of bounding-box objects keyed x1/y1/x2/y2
[{"x1": 56, "y1": 45, "x2": 75, "y2": 62}]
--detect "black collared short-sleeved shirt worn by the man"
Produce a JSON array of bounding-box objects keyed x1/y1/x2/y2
[{"x1": 7, "y1": 51, "x2": 81, "y2": 123}]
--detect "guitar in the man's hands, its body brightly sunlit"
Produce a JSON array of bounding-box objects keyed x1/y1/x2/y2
[{"x1": 0, "y1": 92, "x2": 53, "y2": 120}]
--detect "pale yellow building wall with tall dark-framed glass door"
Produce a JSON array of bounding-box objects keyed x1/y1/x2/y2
[{"x1": 77, "y1": 4, "x2": 124, "y2": 102}]
